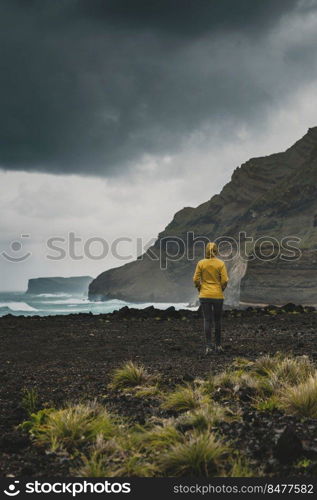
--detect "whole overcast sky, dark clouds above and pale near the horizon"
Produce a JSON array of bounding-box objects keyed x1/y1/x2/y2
[{"x1": 0, "y1": 0, "x2": 317, "y2": 290}]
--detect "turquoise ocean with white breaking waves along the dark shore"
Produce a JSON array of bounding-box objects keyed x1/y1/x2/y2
[{"x1": 0, "y1": 292, "x2": 197, "y2": 317}]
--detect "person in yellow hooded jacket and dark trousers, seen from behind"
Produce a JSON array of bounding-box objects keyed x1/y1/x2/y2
[{"x1": 193, "y1": 242, "x2": 228, "y2": 355}]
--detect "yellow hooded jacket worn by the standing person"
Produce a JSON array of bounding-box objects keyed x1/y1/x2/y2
[{"x1": 193, "y1": 243, "x2": 228, "y2": 299}]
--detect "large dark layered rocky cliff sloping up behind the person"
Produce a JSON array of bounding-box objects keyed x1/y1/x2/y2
[{"x1": 89, "y1": 127, "x2": 317, "y2": 304}]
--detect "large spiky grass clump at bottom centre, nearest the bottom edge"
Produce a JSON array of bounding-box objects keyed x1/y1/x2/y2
[{"x1": 159, "y1": 432, "x2": 228, "y2": 477}]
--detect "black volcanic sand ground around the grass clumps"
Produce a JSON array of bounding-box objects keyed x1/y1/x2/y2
[{"x1": 0, "y1": 308, "x2": 317, "y2": 476}]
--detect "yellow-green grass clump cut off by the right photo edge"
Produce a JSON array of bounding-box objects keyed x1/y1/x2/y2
[{"x1": 279, "y1": 372, "x2": 317, "y2": 418}]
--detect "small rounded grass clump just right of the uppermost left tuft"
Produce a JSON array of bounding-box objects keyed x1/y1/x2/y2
[{"x1": 161, "y1": 386, "x2": 209, "y2": 412}]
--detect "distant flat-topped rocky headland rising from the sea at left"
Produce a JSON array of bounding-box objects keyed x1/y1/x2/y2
[{"x1": 26, "y1": 276, "x2": 93, "y2": 295}]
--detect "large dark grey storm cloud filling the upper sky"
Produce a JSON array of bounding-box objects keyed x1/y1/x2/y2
[{"x1": 0, "y1": 0, "x2": 306, "y2": 175}]
